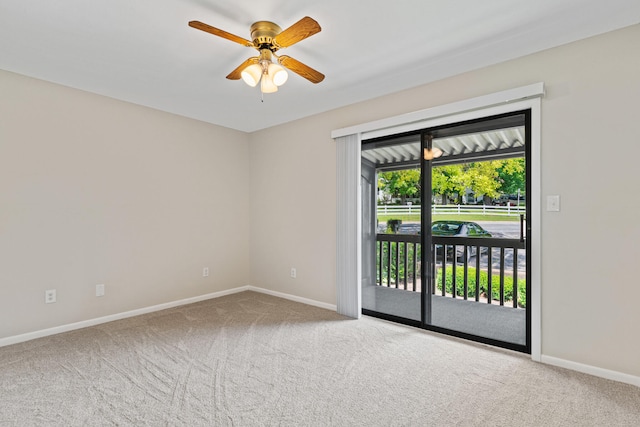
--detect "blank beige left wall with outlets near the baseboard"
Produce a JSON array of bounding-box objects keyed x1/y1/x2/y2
[{"x1": 0, "y1": 71, "x2": 250, "y2": 338}]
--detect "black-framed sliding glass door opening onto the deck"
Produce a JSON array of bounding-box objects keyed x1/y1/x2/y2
[{"x1": 362, "y1": 111, "x2": 531, "y2": 352}]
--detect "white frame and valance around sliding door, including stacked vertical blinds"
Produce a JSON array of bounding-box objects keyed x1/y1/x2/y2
[{"x1": 331, "y1": 83, "x2": 544, "y2": 361}]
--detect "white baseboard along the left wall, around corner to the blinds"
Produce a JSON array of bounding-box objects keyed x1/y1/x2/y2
[{"x1": 0, "y1": 286, "x2": 336, "y2": 347}]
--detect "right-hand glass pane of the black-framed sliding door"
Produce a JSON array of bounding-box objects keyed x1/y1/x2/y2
[{"x1": 425, "y1": 116, "x2": 526, "y2": 345}]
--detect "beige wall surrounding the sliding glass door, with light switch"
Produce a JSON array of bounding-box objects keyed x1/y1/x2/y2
[{"x1": 250, "y1": 25, "x2": 640, "y2": 376}]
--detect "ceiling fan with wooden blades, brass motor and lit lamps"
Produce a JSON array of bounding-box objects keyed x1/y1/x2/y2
[{"x1": 189, "y1": 16, "x2": 324, "y2": 93}]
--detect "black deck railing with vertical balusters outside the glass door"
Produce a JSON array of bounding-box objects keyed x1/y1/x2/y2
[{"x1": 376, "y1": 234, "x2": 526, "y2": 308}]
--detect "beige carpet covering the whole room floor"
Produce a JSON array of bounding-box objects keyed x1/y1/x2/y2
[{"x1": 0, "y1": 292, "x2": 640, "y2": 426}]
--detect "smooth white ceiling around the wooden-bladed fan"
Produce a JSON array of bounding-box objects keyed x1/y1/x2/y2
[{"x1": 0, "y1": 0, "x2": 640, "y2": 132}]
